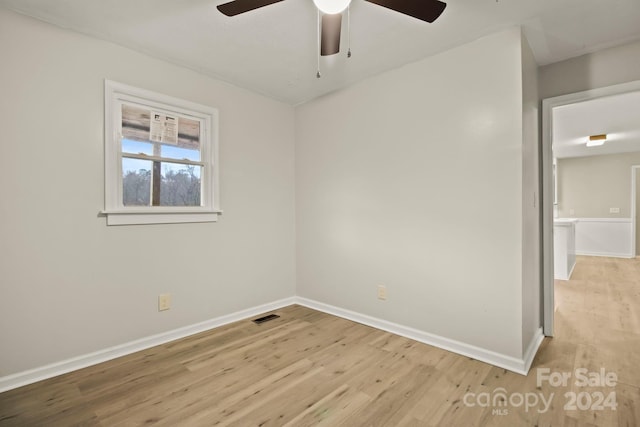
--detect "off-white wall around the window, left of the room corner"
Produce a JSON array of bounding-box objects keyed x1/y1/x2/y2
[{"x1": 0, "y1": 9, "x2": 295, "y2": 376}]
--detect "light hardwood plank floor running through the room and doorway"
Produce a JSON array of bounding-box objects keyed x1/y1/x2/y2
[{"x1": 0, "y1": 257, "x2": 640, "y2": 427}]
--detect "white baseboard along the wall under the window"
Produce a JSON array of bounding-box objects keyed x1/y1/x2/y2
[{"x1": 0, "y1": 297, "x2": 295, "y2": 393}]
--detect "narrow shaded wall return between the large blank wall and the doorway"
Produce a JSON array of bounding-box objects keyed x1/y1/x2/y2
[{"x1": 522, "y1": 35, "x2": 541, "y2": 352}]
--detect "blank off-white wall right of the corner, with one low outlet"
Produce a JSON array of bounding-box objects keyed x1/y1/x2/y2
[{"x1": 296, "y1": 29, "x2": 533, "y2": 358}]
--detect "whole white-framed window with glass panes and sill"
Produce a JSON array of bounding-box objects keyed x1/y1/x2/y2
[{"x1": 103, "y1": 80, "x2": 221, "y2": 225}]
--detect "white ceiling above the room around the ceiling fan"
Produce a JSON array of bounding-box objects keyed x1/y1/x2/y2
[{"x1": 0, "y1": 0, "x2": 640, "y2": 105}]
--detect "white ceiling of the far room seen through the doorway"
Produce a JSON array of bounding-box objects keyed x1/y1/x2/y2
[{"x1": 553, "y1": 91, "x2": 640, "y2": 158}]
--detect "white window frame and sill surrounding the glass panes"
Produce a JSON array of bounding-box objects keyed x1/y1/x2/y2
[{"x1": 102, "y1": 80, "x2": 222, "y2": 225}]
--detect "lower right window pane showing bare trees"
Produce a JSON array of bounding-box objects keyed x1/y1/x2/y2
[{"x1": 160, "y1": 162, "x2": 202, "y2": 206}]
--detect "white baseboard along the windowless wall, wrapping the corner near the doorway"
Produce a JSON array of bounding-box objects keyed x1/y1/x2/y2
[{"x1": 295, "y1": 297, "x2": 544, "y2": 375}]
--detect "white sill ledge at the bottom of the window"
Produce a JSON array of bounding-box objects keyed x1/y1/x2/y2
[{"x1": 100, "y1": 209, "x2": 222, "y2": 225}]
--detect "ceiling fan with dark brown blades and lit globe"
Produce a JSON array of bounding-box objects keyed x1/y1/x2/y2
[{"x1": 218, "y1": 0, "x2": 447, "y2": 56}]
